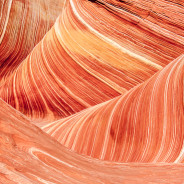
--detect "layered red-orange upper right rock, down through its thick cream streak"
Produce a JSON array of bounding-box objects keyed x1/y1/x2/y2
[{"x1": 69, "y1": 0, "x2": 184, "y2": 67}]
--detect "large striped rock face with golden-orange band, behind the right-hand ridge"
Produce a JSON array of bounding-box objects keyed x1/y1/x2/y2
[{"x1": 0, "y1": 0, "x2": 184, "y2": 121}]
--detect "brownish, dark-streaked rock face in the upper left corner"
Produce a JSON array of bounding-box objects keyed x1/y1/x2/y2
[{"x1": 0, "y1": 0, "x2": 64, "y2": 82}]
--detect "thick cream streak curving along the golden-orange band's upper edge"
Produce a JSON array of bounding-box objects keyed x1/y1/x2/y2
[{"x1": 70, "y1": 0, "x2": 163, "y2": 70}]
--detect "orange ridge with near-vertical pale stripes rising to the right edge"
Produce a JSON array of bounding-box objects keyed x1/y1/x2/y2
[{"x1": 41, "y1": 55, "x2": 184, "y2": 163}]
